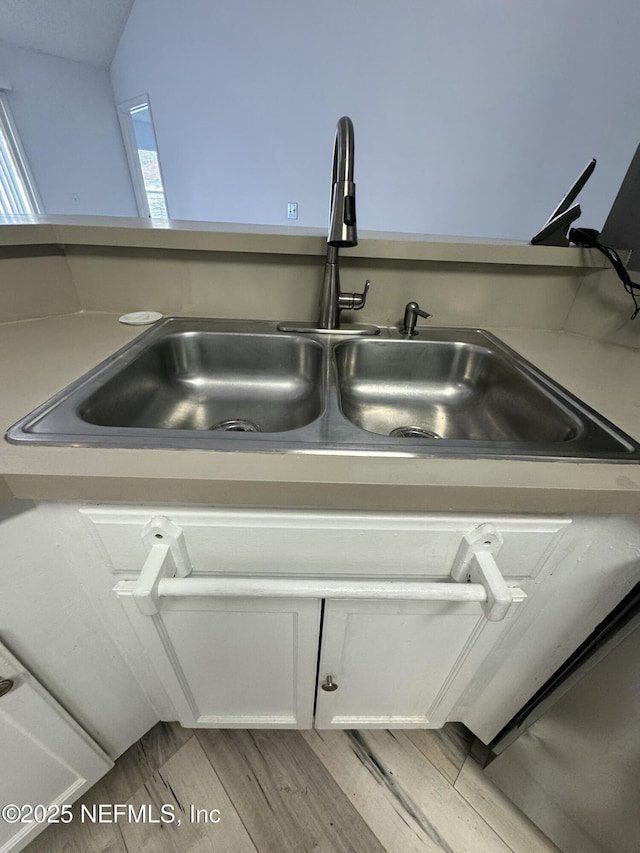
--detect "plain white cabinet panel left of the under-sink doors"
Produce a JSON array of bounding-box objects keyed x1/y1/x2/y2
[{"x1": 0, "y1": 501, "x2": 160, "y2": 758}]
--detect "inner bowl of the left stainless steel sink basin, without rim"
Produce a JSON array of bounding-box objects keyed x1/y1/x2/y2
[{"x1": 78, "y1": 331, "x2": 322, "y2": 432}]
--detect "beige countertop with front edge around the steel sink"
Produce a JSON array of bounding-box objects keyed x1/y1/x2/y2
[{"x1": 0, "y1": 313, "x2": 640, "y2": 513}]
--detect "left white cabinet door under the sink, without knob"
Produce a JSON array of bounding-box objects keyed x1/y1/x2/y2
[{"x1": 118, "y1": 592, "x2": 320, "y2": 728}]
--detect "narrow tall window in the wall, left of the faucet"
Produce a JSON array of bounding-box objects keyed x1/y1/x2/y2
[{"x1": 118, "y1": 95, "x2": 169, "y2": 219}]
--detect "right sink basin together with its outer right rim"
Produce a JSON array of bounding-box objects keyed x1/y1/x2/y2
[{"x1": 334, "y1": 328, "x2": 636, "y2": 458}]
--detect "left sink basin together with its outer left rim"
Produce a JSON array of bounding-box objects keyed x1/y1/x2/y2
[{"x1": 7, "y1": 318, "x2": 325, "y2": 447}]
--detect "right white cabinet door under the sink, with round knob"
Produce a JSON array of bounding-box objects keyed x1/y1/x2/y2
[{"x1": 316, "y1": 600, "x2": 492, "y2": 728}]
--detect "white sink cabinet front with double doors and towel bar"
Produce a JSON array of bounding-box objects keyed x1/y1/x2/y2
[{"x1": 81, "y1": 507, "x2": 571, "y2": 728}]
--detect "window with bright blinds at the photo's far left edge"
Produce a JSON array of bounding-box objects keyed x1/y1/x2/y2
[{"x1": 0, "y1": 94, "x2": 42, "y2": 214}]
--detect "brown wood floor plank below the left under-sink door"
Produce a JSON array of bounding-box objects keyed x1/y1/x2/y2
[{"x1": 197, "y1": 729, "x2": 386, "y2": 853}]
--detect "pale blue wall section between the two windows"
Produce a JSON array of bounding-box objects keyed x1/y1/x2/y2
[{"x1": 0, "y1": 42, "x2": 137, "y2": 216}]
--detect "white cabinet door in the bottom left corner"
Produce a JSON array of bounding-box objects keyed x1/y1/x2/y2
[{"x1": 0, "y1": 645, "x2": 113, "y2": 853}]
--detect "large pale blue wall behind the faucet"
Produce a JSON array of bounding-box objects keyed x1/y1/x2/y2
[{"x1": 111, "y1": 0, "x2": 640, "y2": 240}]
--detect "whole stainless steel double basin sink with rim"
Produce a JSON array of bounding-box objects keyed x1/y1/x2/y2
[{"x1": 7, "y1": 317, "x2": 640, "y2": 462}]
